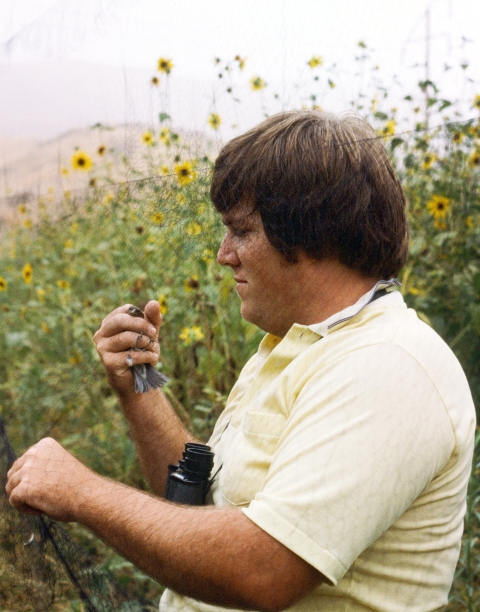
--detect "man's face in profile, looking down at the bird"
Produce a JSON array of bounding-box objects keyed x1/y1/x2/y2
[{"x1": 217, "y1": 204, "x2": 304, "y2": 336}]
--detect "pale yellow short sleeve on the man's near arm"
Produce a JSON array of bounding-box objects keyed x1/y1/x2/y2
[{"x1": 243, "y1": 343, "x2": 455, "y2": 585}]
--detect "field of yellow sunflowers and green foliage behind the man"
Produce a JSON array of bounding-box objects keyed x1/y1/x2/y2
[{"x1": 0, "y1": 50, "x2": 480, "y2": 612}]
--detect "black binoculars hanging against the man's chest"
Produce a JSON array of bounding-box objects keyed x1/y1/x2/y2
[{"x1": 165, "y1": 442, "x2": 217, "y2": 506}]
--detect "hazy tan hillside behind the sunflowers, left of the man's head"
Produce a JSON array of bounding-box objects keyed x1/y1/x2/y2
[{"x1": 0, "y1": 125, "x2": 218, "y2": 220}]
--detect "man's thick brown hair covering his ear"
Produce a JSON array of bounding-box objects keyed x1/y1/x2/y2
[{"x1": 210, "y1": 110, "x2": 408, "y2": 278}]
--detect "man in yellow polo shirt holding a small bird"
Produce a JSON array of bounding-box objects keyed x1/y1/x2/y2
[{"x1": 7, "y1": 111, "x2": 475, "y2": 612}]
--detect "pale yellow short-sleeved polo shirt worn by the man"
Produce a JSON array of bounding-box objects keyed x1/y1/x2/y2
[{"x1": 160, "y1": 292, "x2": 475, "y2": 612}]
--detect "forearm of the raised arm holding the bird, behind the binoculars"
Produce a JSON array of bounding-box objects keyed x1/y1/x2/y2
[{"x1": 119, "y1": 390, "x2": 194, "y2": 496}]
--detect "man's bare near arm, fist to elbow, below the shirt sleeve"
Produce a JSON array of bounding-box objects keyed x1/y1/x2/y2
[{"x1": 6, "y1": 438, "x2": 322, "y2": 612}]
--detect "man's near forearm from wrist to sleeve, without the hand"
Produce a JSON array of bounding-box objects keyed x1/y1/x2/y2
[{"x1": 77, "y1": 479, "x2": 318, "y2": 610}]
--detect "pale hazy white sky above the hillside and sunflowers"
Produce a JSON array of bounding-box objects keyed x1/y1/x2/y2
[{"x1": 0, "y1": 0, "x2": 480, "y2": 137}]
